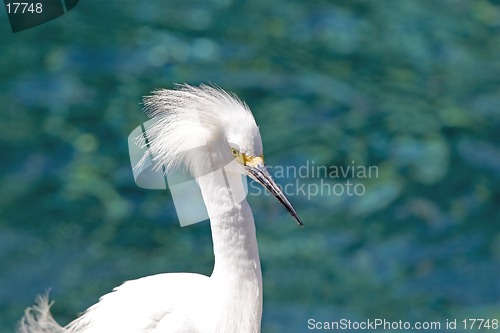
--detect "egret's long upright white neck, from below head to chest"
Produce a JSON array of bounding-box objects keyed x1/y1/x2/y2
[{"x1": 198, "y1": 170, "x2": 262, "y2": 333}]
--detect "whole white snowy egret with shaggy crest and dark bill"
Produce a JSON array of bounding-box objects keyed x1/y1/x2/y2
[{"x1": 18, "y1": 85, "x2": 302, "y2": 333}]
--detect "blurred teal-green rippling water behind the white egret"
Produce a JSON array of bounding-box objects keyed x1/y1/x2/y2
[{"x1": 0, "y1": 0, "x2": 500, "y2": 333}]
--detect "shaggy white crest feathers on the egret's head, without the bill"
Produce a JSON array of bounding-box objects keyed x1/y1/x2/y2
[{"x1": 136, "y1": 84, "x2": 262, "y2": 176}]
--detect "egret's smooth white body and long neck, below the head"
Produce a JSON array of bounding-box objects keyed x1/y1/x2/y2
[{"x1": 63, "y1": 173, "x2": 262, "y2": 333}]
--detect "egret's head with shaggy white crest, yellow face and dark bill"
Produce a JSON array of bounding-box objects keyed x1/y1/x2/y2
[{"x1": 135, "y1": 84, "x2": 302, "y2": 225}]
